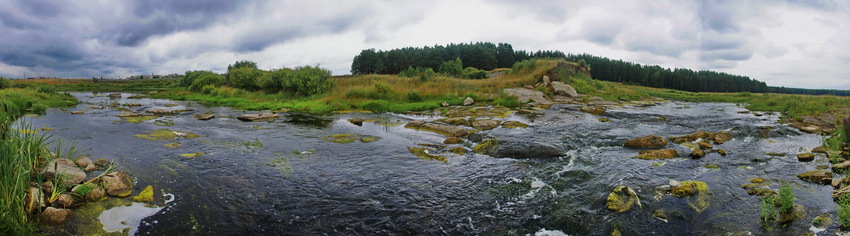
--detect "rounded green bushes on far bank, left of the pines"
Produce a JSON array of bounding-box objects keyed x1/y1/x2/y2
[{"x1": 178, "y1": 61, "x2": 333, "y2": 96}]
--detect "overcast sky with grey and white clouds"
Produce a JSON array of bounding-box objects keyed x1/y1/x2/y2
[{"x1": 0, "y1": 0, "x2": 850, "y2": 89}]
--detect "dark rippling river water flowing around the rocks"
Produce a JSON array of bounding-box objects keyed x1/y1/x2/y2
[{"x1": 27, "y1": 93, "x2": 836, "y2": 235}]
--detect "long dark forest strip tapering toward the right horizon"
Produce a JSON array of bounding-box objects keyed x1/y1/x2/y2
[{"x1": 566, "y1": 54, "x2": 770, "y2": 93}]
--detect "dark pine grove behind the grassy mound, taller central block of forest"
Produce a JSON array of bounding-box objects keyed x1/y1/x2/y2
[{"x1": 351, "y1": 42, "x2": 566, "y2": 75}]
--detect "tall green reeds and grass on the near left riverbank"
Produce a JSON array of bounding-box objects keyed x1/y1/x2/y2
[{"x1": 0, "y1": 89, "x2": 76, "y2": 235}]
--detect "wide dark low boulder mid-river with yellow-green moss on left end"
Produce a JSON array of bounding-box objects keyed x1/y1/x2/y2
[{"x1": 473, "y1": 139, "x2": 564, "y2": 159}]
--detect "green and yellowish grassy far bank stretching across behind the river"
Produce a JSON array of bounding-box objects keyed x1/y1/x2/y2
[{"x1": 13, "y1": 60, "x2": 850, "y2": 118}]
